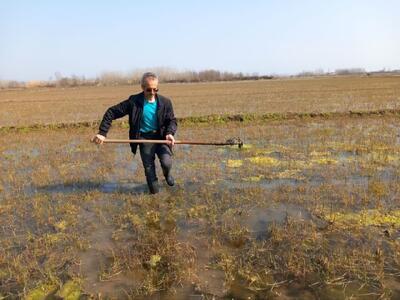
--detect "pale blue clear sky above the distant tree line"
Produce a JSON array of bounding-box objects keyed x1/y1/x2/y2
[{"x1": 0, "y1": 0, "x2": 400, "y2": 80}]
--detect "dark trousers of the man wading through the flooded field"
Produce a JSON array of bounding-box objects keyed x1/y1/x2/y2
[{"x1": 139, "y1": 133, "x2": 172, "y2": 184}]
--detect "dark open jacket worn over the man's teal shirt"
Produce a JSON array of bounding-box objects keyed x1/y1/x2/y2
[{"x1": 99, "y1": 92, "x2": 177, "y2": 153}]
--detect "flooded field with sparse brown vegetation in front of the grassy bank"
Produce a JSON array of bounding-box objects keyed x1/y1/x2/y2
[{"x1": 0, "y1": 116, "x2": 400, "y2": 299}]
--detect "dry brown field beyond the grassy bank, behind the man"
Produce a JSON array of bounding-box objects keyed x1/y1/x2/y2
[{"x1": 0, "y1": 76, "x2": 400, "y2": 126}]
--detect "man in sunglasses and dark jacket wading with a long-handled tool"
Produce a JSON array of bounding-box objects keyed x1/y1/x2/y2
[{"x1": 93, "y1": 72, "x2": 177, "y2": 194}]
